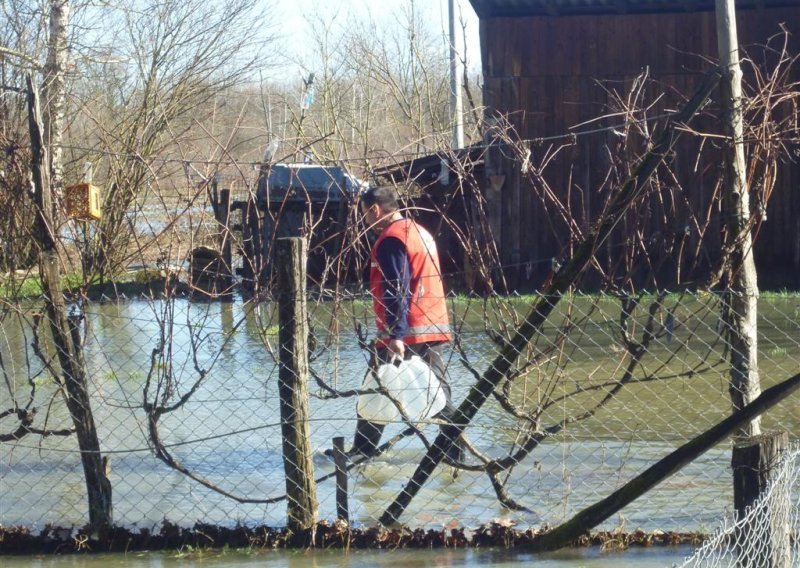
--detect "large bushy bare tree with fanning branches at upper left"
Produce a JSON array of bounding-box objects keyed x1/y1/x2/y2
[{"x1": 62, "y1": 0, "x2": 273, "y2": 274}]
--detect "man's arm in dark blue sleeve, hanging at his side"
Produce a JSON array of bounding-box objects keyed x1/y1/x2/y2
[{"x1": 375, "y1": 237, "x2": 411, "y2": 351}]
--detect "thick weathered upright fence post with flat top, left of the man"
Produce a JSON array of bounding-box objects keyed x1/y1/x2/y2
[{"x1": 275, "y1": 237, "x2": 317, "y2": 544}]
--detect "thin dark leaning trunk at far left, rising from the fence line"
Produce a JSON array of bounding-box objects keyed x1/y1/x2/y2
[{"x1": 27, "y1": 77, "x2": 112, "y2": 530}]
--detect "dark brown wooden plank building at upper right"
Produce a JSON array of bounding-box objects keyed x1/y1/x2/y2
[{"x1": 470, "y1": 0, "x2": 800, "y2": 288}]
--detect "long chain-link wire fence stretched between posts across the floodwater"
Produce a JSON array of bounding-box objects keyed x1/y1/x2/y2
[{"x1": 0, "y1": 286, "x2": 800, "y2": 532}]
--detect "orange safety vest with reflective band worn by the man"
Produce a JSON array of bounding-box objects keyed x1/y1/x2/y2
[{"x1": 369, "y1": 219, "x2": 451, "y2": 345}]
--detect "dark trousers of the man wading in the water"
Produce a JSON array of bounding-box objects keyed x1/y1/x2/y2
[{"x1": 350, "y1": 343, "x2": 462, "y2": 461}]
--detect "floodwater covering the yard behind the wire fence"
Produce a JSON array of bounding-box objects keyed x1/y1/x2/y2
[{"x1": 0, "y1": 292, "x2": 800, "y2": 536}]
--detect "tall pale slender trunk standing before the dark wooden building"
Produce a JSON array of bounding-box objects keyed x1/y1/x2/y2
[{"x1": 716, "y1": 0, "x2": 761, "y2": 436}]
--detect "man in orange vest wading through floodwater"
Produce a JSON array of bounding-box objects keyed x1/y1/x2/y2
[{"x1": 348, "y1": 187, "x2": 461, "y2": 461}]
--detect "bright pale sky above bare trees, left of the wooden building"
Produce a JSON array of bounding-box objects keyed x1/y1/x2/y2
[{"x1": 278, "y1": 0, "x2": 481, "y2": 75}]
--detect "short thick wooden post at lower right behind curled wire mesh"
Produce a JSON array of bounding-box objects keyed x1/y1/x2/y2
[{"x1": 731, "y1": 431, "x2": 791, "y2": 568}]
